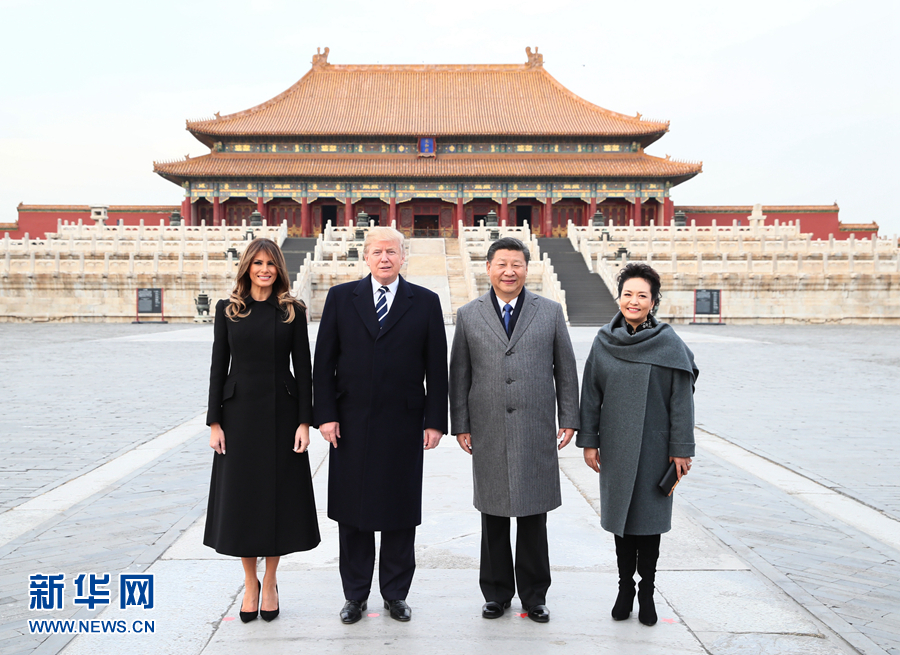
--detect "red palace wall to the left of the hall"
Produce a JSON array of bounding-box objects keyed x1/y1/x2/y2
[{"x1": 6, "y1": 204, "x2": 181, "y2": 239}]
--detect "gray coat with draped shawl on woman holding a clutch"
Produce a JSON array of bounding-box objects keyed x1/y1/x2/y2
[{"x1": 575, "y1": 312, "x2": 697, "y2": 536}]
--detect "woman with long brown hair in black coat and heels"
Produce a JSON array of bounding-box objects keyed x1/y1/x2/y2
[{"x1": 203, "y1": 239, "x2": 320, "y2": 623}]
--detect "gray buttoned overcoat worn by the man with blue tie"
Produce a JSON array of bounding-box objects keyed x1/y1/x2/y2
[{"x1": 450, "y1": 289, "x2": 579, "y2": 516}]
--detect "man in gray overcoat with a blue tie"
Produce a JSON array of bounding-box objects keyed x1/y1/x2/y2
[{"x1": 450, "y1": 238, "x2": 579, "y2": 623}]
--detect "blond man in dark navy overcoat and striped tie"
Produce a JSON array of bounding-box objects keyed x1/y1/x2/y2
[{"x1": 313, "y1": 227, "x2": 447, "y2": 623}]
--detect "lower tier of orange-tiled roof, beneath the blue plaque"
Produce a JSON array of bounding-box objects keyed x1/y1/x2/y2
[{"x1": 153, "y1": 152, "x2": 702, "y2": 181}]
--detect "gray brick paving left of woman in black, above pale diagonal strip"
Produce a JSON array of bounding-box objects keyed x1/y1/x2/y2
[{"x1": 0, "y1": 323, "x2": 209, "y2": 511}]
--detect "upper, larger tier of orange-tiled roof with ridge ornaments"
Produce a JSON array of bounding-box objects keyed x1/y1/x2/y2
[{"x1": 187, "y1": 52, "x2": 668, "y2": 144}]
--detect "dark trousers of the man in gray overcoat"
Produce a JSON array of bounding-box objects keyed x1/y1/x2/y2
[{"x1": 480, "y1": 512, "x2": 550, "y2": 607}]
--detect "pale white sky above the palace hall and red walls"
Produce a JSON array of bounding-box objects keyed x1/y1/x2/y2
[{"x1": 0, "y1": 0, "x2": 900, "y2": 234}]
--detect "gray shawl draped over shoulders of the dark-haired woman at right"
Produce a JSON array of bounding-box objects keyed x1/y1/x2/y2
[{"x1": 597, "y1": 312, "x2": 700, "y2": 384}]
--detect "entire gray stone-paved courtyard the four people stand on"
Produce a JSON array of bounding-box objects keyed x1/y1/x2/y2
[{"x1": 0, "y1": 324, "x2": 900, "y2": 655}]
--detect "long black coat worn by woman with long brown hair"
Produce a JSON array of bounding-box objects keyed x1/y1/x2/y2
[{"x1": 203, "y1": 294, "x2": 320, "y2": 557}]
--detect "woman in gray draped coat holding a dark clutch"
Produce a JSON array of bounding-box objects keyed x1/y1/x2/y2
[{"x1": 576, "y1": 263, "x2": 698, "y2": 625}]
